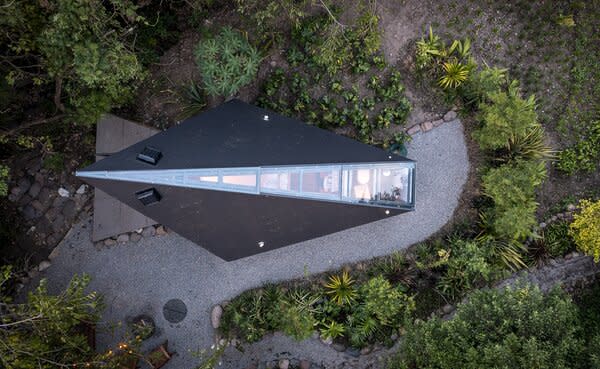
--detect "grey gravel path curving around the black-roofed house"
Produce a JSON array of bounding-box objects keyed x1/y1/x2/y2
[{"x1": 36, "y1": 120, "x2": 469, "y2": 369}]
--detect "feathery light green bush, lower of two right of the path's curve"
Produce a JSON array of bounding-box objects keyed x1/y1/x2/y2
[{"x1": 482, "y1": 160, "x2": 546, "y2": 240}]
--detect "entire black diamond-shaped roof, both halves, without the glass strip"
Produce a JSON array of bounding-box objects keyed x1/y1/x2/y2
[{"x1": 80, "y1": 100, "x2": 410, "y2": 260}]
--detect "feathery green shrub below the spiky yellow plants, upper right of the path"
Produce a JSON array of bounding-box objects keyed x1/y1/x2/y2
[{"x1": 473, "y1": 83, "x2": 538, "y2": 150}]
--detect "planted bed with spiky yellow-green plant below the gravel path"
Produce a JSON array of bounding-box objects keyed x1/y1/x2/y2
[{"x1": 221, "y1": 273, "x2": 414, "y2": 347}]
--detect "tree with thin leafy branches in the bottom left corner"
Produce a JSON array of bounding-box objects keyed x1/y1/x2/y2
[{"x1": 0, "y1": 267, "x2": 141, "y2": 369}]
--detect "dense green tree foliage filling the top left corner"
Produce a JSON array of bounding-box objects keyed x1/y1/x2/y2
[{"x1": 0, "y1": 0, "x2": 143, "y2": 124}]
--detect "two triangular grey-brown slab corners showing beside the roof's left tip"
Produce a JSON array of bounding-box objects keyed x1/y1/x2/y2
[{"x1": 92, "y1": 114, "x2": 160, "y2": 242}]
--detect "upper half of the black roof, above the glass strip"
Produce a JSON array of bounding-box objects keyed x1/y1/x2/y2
[{"x1": 81, "y1": 100, "x2": 410, "y2": 172}]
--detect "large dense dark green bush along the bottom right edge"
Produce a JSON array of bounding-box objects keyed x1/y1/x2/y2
[{"x1": 389, "y1": 286, "x2": 583, "y2": 369}]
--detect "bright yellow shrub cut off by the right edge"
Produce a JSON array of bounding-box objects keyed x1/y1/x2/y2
[{"x1": 570, "y1": 200, "x2": 600, "y2": 263}]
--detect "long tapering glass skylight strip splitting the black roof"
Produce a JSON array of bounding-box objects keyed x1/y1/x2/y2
[{"x1": 77, "y1": 162, "x2": 415, "y2": 209}]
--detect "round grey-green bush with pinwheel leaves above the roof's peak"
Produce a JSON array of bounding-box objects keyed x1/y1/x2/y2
[{"x1": 194, "y1": 27, "x2": 262, "y2": 96}]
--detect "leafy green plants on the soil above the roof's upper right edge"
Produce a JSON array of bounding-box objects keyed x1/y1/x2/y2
[{"x1": 257, "y1": 9, "x2": 411, "y2": 147}]
